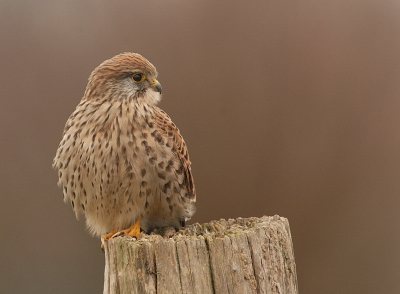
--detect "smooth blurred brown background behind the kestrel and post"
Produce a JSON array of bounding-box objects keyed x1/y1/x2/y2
[{"x1": 0, "y1": 0, "x2": 400, "y2": 293}]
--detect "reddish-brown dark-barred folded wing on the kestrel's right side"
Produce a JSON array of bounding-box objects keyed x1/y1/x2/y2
[{"x1": 154, "y1": 106, "x2": 196, "y2": 201}]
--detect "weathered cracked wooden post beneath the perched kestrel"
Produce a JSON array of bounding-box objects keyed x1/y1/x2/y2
[{"x1": 104, "y1": 216, "x2": 298, "y2": 294}]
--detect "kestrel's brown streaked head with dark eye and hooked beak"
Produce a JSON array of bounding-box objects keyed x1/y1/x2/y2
[{"x1": 83, "y1": 53, "x2": 161, "y2": 105}]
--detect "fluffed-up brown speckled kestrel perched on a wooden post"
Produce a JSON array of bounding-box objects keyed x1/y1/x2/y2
[{"x1": 53, "y1": 53, "x2": 196, "y2": 243}]
